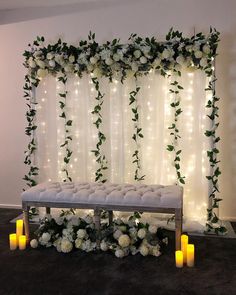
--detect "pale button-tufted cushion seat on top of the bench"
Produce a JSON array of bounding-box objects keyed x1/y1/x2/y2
[{"x1": 22, "y1": 182, "x2": 183, "y2": 208}]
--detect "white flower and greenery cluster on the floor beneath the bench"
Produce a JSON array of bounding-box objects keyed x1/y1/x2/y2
[{"x1": 30, "y1": 212, "x2": 168, "y2": 258}]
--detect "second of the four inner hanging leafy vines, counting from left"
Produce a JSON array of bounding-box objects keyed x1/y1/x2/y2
[{"x1": 91, "y1": 77, "x2": 108, "y2": 183}]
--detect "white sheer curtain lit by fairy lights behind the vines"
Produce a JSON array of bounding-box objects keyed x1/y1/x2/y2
[{"x1": 36, "y1": 71, "x2": 209, "y2": 221}]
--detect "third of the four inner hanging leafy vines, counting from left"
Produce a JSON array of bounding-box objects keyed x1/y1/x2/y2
[{"x1": 129, "y1": 82, "x2": 145, "y2": 181}]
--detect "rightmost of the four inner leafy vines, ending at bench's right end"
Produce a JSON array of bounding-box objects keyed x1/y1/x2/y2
[{"x1": 167, "y1": 80, "x2": 185, "y2": 184}]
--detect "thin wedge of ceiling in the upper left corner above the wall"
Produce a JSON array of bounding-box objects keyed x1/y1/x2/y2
[{"x1": 0, "y1": 0, "x2": 91, "y2": 11}]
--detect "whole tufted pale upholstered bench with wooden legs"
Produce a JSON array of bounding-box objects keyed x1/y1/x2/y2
[{"x1": 22, "y1": 182, "x2": 183, "y2": 249}]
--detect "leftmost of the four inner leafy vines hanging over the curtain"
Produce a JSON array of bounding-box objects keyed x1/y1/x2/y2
[{"x1": 58, "y1": 74, "x2": 73, "y2": 182}]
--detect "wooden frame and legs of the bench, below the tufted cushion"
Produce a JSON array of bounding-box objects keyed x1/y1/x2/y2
[{"x1": 22, "y1": 201, "x2": 183, "y2": 250}]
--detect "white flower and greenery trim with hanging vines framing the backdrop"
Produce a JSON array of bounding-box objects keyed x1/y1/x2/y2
[{"x1": 24, "y1": 29, "x2": 225, "y2": 240}]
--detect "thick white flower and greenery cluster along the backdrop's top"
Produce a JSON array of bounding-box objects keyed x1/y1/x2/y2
[{"x1": 24, "y1": 29, "x2": 219, "y2": 86}]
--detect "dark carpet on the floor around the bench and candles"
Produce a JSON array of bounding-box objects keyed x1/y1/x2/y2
[{"x1": 0, "y1": 209, "x2": 236, "y2": 295}]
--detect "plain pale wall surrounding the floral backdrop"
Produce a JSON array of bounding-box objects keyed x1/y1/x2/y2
[{"x1": 0, "y1": 0, "x2": 236, "y2": 218}]
